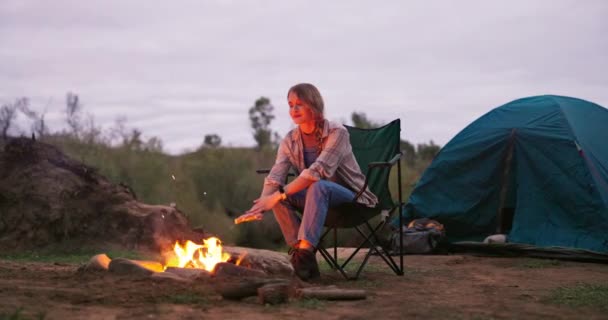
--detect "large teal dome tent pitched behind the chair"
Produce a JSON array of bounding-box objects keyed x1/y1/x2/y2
[{"x1": 404, "y1": 95, "x2": 608, "y2": 253}]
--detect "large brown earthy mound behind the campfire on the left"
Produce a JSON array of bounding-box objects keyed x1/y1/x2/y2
[{"x1": 0, "y1": 138, "x2": 206, "y2": 251}]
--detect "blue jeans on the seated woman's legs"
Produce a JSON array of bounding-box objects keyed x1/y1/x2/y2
[{"x1": 272, "y1": 180, "x2": 355, "y2": 247}]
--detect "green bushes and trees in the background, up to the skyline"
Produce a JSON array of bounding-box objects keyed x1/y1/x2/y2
[{"x1": 5, "y1": 93, "x2": 439, "y2": 250}]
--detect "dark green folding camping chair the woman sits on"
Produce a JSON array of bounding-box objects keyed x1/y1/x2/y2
[{"x1": 257, "y1": 119, "x2": 403, "y2": 280}]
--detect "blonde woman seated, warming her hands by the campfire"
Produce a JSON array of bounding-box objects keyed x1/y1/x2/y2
[{"x1": 247, "y1": 83, "x2": 378, "y2": 280}]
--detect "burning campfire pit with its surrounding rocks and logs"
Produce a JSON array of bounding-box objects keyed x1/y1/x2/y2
[{"x1": 80, "y1": 237, "x2": 365, "y2": 304}]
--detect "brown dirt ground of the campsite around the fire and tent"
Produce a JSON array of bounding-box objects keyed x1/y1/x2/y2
[{"x1": 0, "y1": 250, "x2": 608, "y2": 319}]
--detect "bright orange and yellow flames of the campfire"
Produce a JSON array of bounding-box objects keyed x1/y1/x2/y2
[{"x1": 165, "y1": 237, "x2": 230, "y2": 271}]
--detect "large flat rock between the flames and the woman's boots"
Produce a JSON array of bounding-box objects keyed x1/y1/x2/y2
[{"x1": 224, "y1": 246, "x2": 293, "y2": 276}]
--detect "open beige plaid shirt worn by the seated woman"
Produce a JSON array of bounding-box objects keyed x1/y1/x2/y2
[{"x1": 262, "y1": 120, "x2": 378, "y2": 207}]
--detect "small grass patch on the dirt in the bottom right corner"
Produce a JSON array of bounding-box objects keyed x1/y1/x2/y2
[{"x1": 546, "y1": 283, "x2": 608, "y2": 311}]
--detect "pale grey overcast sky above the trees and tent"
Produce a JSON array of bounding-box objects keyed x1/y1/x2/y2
[{"x1": 0, "y1": 0, "x2": 608, "y2": 154}]
